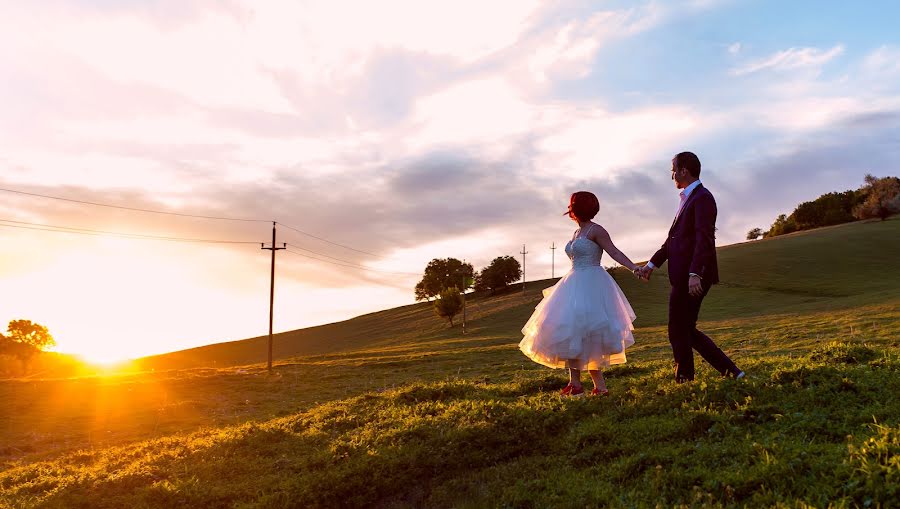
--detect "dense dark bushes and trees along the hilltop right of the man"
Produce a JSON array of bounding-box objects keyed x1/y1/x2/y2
[{"x1": 747, "y1": 175, "x2": 900, "y2": 240}]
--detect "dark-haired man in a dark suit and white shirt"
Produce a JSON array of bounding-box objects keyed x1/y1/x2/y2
[{"x1": 635, "y1": 152, "x2": 744, "y2": 383}]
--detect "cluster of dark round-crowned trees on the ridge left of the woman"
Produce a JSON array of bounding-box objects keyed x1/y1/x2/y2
[{"x1": 415, "y1": 256, "x2": 522, "y2": 327}]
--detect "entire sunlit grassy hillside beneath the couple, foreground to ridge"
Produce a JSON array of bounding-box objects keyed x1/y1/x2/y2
[{"x1": 0, "y1": 219, "x2": 900, "y2": 507}]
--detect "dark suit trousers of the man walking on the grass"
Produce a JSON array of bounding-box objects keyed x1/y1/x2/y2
[{"x1": 669, "y1": 284, "x2": 739, "y2": 382}]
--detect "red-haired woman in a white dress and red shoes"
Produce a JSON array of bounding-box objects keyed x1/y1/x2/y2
[{"x1": 519, "y1": 191, "x2": 637, "y2": 396}]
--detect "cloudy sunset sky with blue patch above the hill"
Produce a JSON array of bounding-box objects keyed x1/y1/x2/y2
[{"x1": 0, "y1": 0, "x2": 900, "y2": 360}]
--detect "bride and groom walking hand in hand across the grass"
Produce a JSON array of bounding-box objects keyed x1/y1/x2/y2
[{"x1": 519, "y1": 152, "x2": 744, "y2": 396}]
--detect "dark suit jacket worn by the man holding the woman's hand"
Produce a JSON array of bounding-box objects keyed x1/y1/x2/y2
[{"x1": 650, "y1": 184, "x2": 719, "y2": 288}]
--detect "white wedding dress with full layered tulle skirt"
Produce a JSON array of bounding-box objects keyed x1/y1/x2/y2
[{"x1": 519, "y1": 224, "x2": 635, "y2": 370}]
